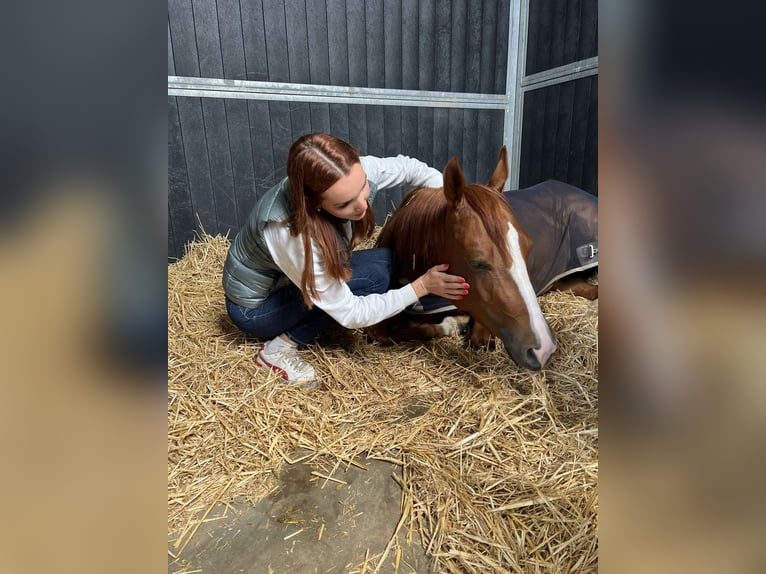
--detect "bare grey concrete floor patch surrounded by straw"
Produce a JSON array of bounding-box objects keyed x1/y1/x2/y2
[{"x1": 168, "y1": 460, "x2": 430, "y2": 574}]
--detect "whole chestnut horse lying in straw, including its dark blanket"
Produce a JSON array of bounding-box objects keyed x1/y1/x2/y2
[{"x1": 368, "y1": 146, "x2": 598, "y2": 370}]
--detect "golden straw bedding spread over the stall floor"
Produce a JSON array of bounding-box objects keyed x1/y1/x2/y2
[{"x1": 168, "y1": 235, "x2": 598, "y2": 573}]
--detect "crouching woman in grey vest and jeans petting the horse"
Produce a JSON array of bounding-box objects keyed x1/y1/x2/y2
[{"x1": 223, "y1": 134, "x2": 468, "y2": 387}]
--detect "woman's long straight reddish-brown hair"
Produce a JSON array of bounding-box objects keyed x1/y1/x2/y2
[{"x1": 287, "y1": 134, "x2": 375, "y2": 309}]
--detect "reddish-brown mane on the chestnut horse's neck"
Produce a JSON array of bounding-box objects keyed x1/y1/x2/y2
[{"x1": 377, "y1": 184, "x2": 513, "y2": 278}]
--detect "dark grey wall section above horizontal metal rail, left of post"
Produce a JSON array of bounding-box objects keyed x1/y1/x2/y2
[{"x1": 168, "y1": 0, "x2": 510, "y2": 93}]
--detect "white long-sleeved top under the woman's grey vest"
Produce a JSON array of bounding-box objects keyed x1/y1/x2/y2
[{"x1": 264, "y1": 155, "x2": 443, "y2": 329}]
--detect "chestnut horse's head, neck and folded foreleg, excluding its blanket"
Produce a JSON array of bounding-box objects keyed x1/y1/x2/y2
[{"x1": 368, "y1": 146, "x2": 597, "y2": 370}]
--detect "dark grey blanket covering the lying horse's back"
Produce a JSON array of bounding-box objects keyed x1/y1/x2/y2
[{"x1": 510, "y1": 180, "x2": 598, "y2": 295}]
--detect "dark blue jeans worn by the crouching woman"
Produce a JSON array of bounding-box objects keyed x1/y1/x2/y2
[{"x1": 226, "y1": 249, "x2": 393, "y2": 345}]
